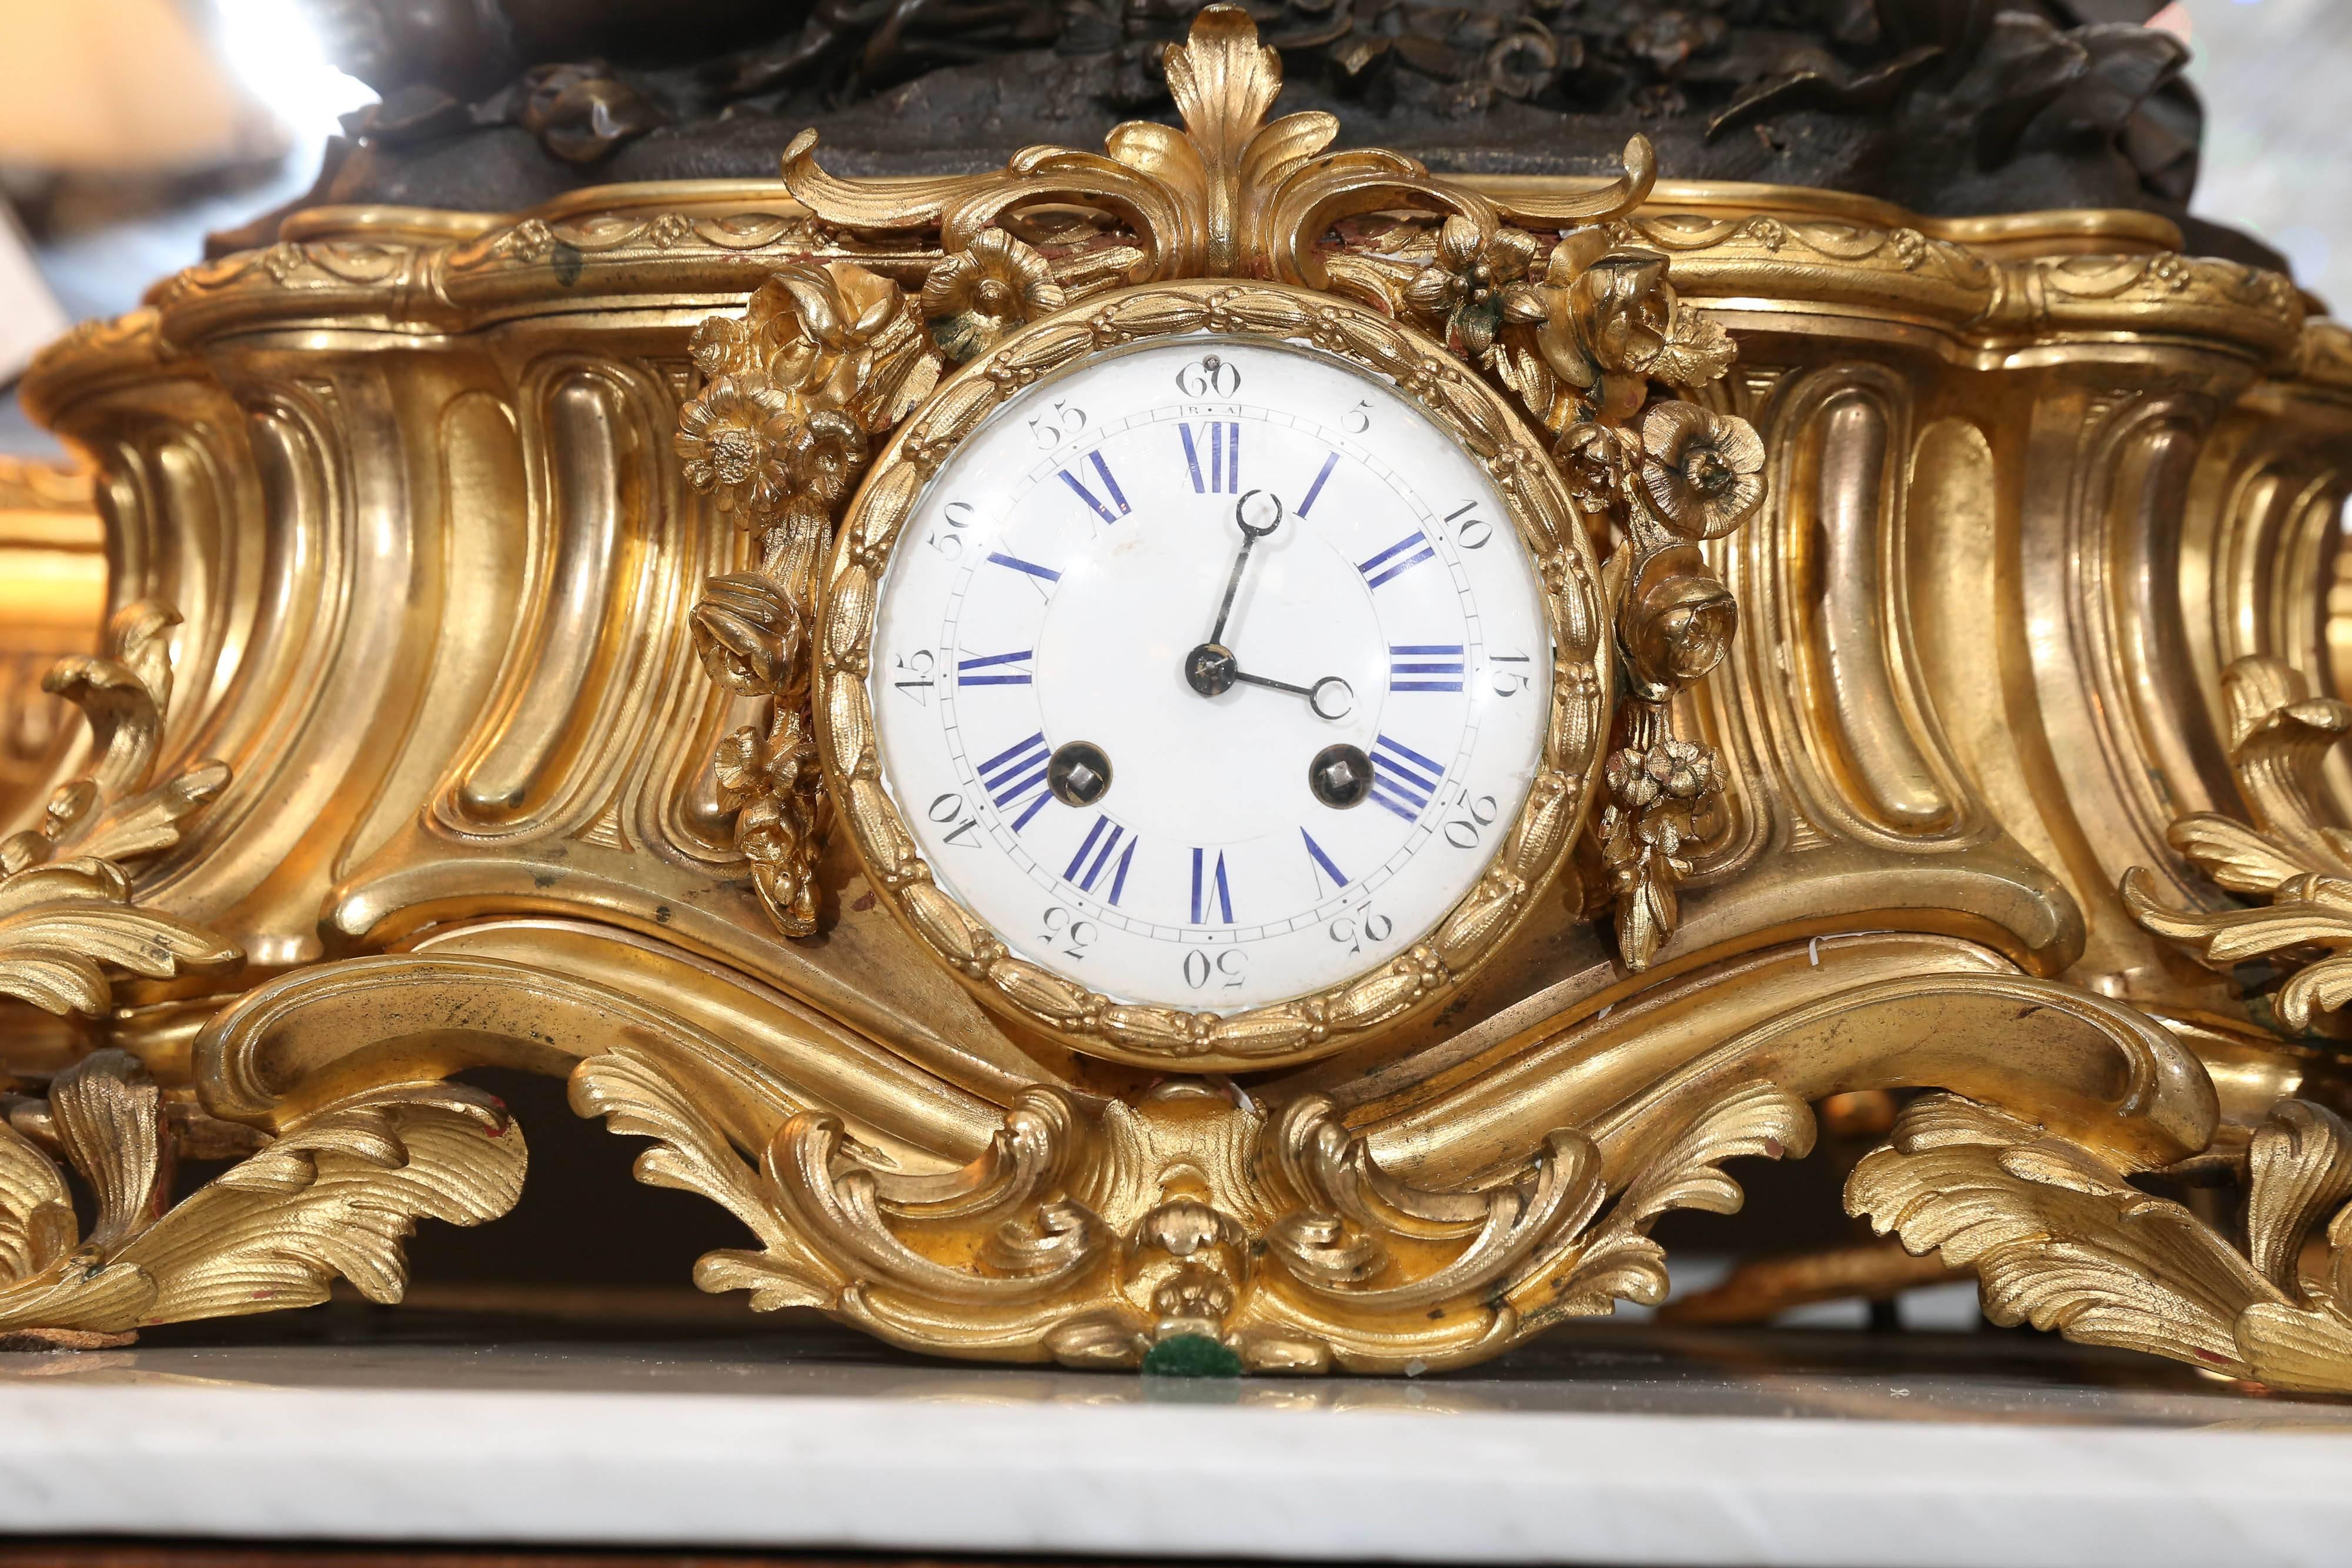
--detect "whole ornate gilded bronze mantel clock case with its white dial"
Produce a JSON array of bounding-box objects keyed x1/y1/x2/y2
[{"x1": 0, "y1": 5, "x2": 2352, "y2": 1392}]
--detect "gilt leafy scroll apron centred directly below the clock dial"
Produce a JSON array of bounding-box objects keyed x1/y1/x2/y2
[{"x1": 572, "y1": 1048, "x2": 1813, "y2": 1370}]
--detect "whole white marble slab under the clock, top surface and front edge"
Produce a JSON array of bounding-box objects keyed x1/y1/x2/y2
[{"x1": 0, "y1": 1342, "x2": 2352, "y2": 1568}]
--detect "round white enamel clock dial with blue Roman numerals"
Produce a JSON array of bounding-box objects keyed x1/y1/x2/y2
[{"x1": 868, "y1": 336, "x2": 1552, "y2": 1013}]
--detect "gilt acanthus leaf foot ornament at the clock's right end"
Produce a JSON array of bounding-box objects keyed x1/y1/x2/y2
[{"x1": 1910, "y1": 656, "x2": 2352, "y2": 1394}]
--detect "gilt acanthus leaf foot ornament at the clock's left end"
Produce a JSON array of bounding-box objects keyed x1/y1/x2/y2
[{"x1": 0, "y1": 600, "x2": 527, "y2": 1349}]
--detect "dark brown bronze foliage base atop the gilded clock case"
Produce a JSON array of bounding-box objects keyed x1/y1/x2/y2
[{"x1": 258, "y1": 0, "x2": 2220, "y2": 261}]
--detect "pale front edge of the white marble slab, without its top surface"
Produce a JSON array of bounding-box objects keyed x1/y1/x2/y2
[{"x1": 0, "y1": 1385, "x2": 2352, "y2": 1568}]
